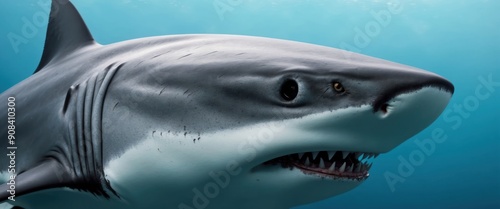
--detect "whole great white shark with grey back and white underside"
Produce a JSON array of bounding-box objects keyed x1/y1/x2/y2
[{"x1": 0, "y1": 0, "x2": 454, "y2": 209}]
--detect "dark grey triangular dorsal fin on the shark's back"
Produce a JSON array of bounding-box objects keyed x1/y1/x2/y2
[{"x1": 35, "y1": 0, "x2": 96, "y2": 73}]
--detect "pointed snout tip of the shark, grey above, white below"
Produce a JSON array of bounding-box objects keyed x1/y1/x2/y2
[{"x1": 352, "y1": 70, "x2": 454, "y2": 152}]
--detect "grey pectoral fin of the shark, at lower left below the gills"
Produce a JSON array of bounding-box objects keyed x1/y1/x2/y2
[{"x1": 0, "y1": 160, "x2": 73, "y2": 202}]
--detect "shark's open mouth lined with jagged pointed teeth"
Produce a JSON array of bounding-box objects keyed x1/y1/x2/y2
[{"x1": 263, "y1": 151, "x2": 378, "y2": 181}]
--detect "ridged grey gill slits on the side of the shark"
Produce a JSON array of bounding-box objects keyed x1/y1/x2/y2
[{"x1": 60, "y1": 63, "x2": 125, "y2": 199}]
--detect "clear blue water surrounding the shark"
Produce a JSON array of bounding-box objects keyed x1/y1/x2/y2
[{"x1": 0, "y1": 0, "x2": 500, "y2": 209}]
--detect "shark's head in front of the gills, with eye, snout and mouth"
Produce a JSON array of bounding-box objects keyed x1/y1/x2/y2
[{"x1": 105, "y1": 35, "x2": 454, "y2": 208}]
